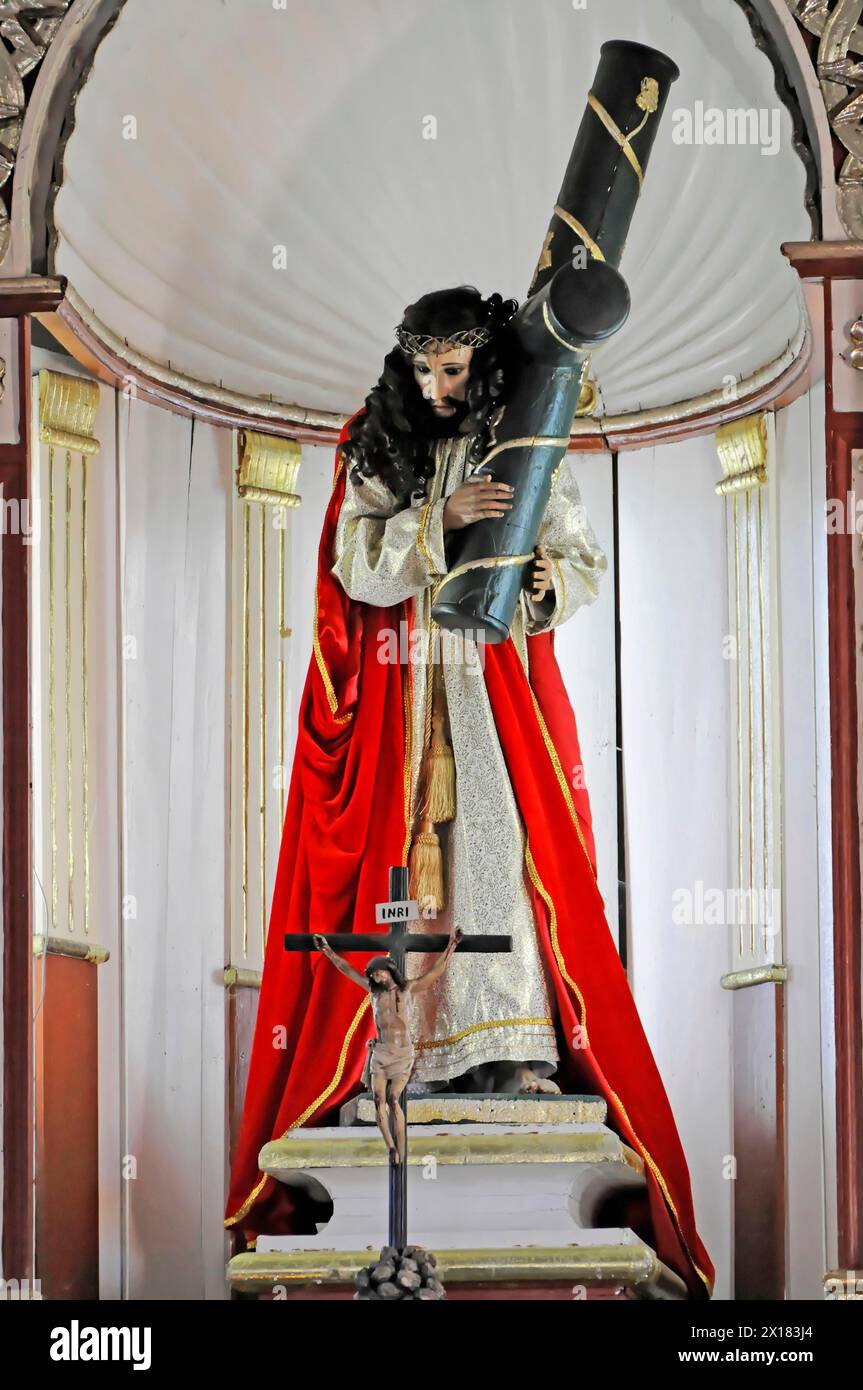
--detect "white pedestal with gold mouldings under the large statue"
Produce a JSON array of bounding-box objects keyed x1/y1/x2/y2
[{"x1": 228, "y1": 1095, "x2": 685, "y2": 1300}]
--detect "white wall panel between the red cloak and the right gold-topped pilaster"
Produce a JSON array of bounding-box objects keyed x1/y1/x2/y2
[{"x1": 620, "y1": 438, "x2": 732, "y2": 1298}]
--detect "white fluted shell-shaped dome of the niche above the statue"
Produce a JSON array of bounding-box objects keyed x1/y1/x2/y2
[{"x1": 54, "y1": 0, "x2": 810, "y2": 414}]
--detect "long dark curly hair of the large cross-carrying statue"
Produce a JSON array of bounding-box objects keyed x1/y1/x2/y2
[{"x1": 342, "y1": 285, "x2": 518, "y2": 499}]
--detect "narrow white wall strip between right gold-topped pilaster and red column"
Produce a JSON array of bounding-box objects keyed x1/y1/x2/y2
[{"x1": 777, "y1": 382, "x2": 838, "y2": 1298}]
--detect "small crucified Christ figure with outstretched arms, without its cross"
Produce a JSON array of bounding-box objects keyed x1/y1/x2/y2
[{"x1": 314, "y1": 927, "x2": 461, "y2": 1163}]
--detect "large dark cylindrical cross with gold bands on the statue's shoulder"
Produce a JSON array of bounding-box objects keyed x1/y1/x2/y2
[{"x1": 432, "y1": 39, "x2": 680, "y2": 642}]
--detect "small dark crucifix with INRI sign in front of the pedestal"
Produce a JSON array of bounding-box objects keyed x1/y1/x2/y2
[{"x1": 285, "y1": 866, "x2": 513, "y2": 1251}]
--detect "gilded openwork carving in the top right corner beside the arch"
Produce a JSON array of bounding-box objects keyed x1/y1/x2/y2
[{"x1": 785, "y1": 0, "x2": 863, "y2": 240}]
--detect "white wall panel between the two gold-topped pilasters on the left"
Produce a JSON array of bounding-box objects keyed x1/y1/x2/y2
[{"x1": 118, "y1": 400, "x2": 232, "y2": 1298}]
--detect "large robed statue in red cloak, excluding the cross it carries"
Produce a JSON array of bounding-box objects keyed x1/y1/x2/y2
[{"x1": 225, "y1": 286, "x2": 713, "y2": 1297}]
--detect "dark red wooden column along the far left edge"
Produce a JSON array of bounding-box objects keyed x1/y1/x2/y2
[{"x1": 0, "y1": 318, "x2": 33, "y2": 1279}]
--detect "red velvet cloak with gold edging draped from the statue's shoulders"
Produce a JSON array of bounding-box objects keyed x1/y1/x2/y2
[{"x1": 225, "y1": 414, "x2": 714, "y2": 1298}]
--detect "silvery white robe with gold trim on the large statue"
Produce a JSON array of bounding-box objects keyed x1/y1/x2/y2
[{"x1": 332, "y1": 435, "x2": 607, "y2": 1083}]
